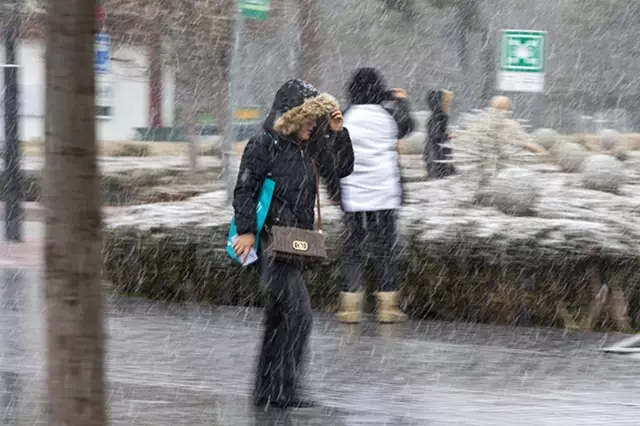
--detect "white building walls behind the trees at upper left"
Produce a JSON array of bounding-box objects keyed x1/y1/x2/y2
[{"x1": 0, "y1": 39, "x2": 175, "y2": 141}]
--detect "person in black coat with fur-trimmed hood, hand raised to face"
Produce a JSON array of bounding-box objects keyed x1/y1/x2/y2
[{"x1": 233, "y1": 80, "x2": 353, "y2": 408}]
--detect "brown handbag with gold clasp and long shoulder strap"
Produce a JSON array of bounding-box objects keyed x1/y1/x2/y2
[{"x1": 265, "y1": 161, "x2": 327, "y2": 263}]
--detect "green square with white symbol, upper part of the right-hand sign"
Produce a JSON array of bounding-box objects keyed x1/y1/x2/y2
[{"x1": 500, "y1": 30, "x2": 546, "y2": 73}]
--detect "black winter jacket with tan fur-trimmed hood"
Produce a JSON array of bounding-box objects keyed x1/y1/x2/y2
[{"x1": 233, "y1": 80, "x2": 353, "y2": 235}]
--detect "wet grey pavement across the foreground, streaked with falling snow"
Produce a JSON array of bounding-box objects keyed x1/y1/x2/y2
[{"x1": 0, "y1": 268, "x2": 640, "y2": 426}]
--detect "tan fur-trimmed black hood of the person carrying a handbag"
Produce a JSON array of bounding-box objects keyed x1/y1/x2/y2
[{"x1": 264, "y1": 79, "x2": 340, "y2": 136}]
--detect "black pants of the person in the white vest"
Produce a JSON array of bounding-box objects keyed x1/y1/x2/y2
[{"x1": 342, "y1": 210, "x2": 399, "y2": 292}]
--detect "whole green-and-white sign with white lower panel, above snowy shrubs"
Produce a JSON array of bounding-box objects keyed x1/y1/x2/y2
[{"x1": 497, "y1": 30, "x2": 547, "y2": 93}]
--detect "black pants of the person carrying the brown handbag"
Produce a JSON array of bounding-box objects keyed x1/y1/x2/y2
[{"x1": 254, "y1": 256, "x2": 313, "y2": 401}]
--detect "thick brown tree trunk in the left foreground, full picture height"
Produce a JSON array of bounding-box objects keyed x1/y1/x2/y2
[{"x1": 42, "y1": 0, "x2": 107, "y2": 426}]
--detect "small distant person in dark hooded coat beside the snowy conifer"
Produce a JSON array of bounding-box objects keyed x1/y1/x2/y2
[{"x1": 424, "y1": 90, "x2": 456, "y2": 179}]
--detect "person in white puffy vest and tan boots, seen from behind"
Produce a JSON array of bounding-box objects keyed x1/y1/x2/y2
[{"x1": 337, "y1": 68, "x2": 413, "y2": 323}]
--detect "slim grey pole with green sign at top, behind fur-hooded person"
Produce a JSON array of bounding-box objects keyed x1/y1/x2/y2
[{"x1": 222, "y1": 0, "x2": 271, "y2": 203}]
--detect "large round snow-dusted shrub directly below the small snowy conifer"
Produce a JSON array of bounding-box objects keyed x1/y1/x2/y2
[{"x1": 488, "y1": 167, "x2": 540, "y2": 216}]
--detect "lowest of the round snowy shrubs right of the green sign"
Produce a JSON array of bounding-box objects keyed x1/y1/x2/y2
[{"x1": 580, "y1": 155, "x2": 625, "y2": 193}]
